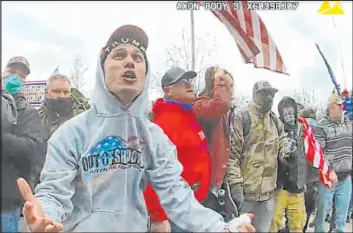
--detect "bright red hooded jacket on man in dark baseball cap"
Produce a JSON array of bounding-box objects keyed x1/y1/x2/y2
[{"x1": 144, "y1": 99, "x2": 210, "y2": 221}]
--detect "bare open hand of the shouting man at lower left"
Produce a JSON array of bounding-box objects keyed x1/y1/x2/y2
[{"x1": 17, "y1": 178, "x2": 63, "y2": 232}]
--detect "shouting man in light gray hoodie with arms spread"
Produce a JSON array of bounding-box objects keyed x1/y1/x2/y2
[{"x1": 17, "y1": 25, "x2": 255, "y2": 232}]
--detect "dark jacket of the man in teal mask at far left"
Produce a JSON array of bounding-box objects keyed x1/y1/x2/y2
[{"x1": 1, "y1": 94, "x2": 45, "y2": 212}]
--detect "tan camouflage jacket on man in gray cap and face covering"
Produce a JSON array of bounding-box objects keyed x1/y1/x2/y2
[{"x1": 226, "y1": 104, "x2": 285, "y2": 201}]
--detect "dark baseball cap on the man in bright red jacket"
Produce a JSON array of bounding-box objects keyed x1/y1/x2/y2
[{"x1": 162, "y1": 67, "x2": 197, "y2": 88}]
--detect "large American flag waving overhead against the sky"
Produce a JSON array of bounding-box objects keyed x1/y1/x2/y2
[{"x1": 199, "y1": 1, "x2": 288, "y2": 75}]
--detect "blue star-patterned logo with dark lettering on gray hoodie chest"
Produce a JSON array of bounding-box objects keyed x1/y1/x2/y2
[{"x1": 81, "y1": 136, "x2": 144, "y2": 179}]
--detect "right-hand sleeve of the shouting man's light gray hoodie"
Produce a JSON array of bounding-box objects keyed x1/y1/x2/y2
[{"x1": 146, "y1": 128, "x2": 226, "y2": 232}]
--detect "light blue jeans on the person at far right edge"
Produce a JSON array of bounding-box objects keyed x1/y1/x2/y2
[{"x1": 315, "y1": 176, "x2": 352, "y2": 232}]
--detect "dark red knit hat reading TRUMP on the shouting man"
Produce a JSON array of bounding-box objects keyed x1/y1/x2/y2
[{"x1": 101, "y1": 25, "x2": 148, "y2": 72}]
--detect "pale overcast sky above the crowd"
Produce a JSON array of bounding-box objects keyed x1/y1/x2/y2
[{"x1": 1, "y1": 1, "x2": 352, "y2": 109}]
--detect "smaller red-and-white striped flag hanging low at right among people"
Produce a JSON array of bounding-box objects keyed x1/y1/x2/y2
[{"x1": 298, "y1": 117, "x2": 332, "y2": 188}]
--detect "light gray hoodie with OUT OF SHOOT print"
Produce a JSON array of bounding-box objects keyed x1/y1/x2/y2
[{"x1": 35, "y1": 54, "x2": 226, "y2": 232}]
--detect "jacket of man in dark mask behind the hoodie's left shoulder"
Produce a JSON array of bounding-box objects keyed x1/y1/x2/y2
[{"x1": 39, "y1": 97, "x2": 86, "y2": 141}]
